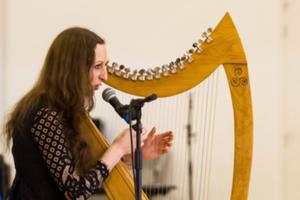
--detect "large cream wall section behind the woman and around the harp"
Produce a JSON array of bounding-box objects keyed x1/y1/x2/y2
[{"x1": 3, "y1": 0, "x2": 290, "y2": 200}]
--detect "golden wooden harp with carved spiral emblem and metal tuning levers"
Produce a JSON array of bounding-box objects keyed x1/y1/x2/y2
[{"x1": 81, "y1": 13, "x2": 253, "y2": 200}]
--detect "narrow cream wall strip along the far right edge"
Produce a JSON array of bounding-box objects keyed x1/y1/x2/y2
[{"x1": 282, "y1": 0, "x2": 300, "y2": 199}]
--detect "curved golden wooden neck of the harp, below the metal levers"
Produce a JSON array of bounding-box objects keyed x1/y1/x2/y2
[{"x1": 106, "y1": 13, "x2": 247, "y2": 97}]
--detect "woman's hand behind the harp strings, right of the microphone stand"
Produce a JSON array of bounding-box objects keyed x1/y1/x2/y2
[{"x1": 142, "y1": 127, "x2": 174, "y2": 160}]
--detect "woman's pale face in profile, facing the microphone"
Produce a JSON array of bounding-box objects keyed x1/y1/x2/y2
[{"x1": 90, "y1": 44, "x2": 108, "y2": 90}]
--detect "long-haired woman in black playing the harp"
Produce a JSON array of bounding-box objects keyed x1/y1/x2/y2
[{"x1": 5, "y1": 27, "x2": 173, "y2": 200}]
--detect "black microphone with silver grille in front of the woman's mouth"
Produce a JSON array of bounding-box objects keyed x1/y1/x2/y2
[{"x1": 102, "y1": 88, "x2": 129, "y2": 123}]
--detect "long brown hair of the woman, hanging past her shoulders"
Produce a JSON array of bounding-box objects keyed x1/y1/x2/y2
[{"x1": 4, "y1": 27, "x2": 105, "y2": 173}]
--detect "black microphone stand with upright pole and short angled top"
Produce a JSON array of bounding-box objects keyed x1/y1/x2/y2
[{"x1": 129, "y1": 94, "x2": 157, "y2": 200}]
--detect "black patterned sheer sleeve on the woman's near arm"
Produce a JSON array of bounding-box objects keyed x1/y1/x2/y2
[{"x1": 31, "y1": 108, "x2": 104, "y2": 199}]
